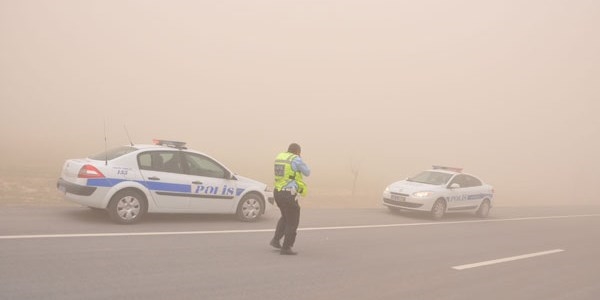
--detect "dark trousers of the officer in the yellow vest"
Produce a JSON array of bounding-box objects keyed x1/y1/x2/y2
[{"x1": 273, "y1": 191, "x2": 300, "y2": 248}]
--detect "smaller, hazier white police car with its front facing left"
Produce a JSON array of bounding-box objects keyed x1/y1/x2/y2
[{"x1": 383, "y1": 166, "x2": 494, "y2": 219}]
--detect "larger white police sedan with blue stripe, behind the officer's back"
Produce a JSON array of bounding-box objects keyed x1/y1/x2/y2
[{"x1": 57, "y1": 140, "x2": 273, "y2": 224}]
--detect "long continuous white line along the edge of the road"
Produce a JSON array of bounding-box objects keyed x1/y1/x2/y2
[{"x1": 0, "y1": 214, "x2": 600, "y2": 240}]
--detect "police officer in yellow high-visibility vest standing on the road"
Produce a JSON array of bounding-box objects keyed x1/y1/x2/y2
[{"x1": 270, "y1": 143, "x2": 310, "y2": 255}]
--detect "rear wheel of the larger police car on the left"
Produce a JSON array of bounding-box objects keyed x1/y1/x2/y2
[{"x1": 108, "y1": 190, "x2": 148, "y2": 224}]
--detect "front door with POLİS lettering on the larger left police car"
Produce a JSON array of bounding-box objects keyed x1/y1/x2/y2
[{"x1": 184, "y1": 152, "x2": 238, "y2": 213}]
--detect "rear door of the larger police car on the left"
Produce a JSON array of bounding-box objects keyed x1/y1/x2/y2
[{"x1": 138, "y1": 150, "x2": 191, "y2": 211}]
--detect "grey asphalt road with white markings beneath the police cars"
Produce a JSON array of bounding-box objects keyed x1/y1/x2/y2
[{"x1": 0, "y1": 206, "x2": 600, "y2": 300}]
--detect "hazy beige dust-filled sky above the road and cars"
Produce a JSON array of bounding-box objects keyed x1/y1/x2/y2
[{"x1": 0, "y1": 0, "x2": 600, "y2": 205}]
